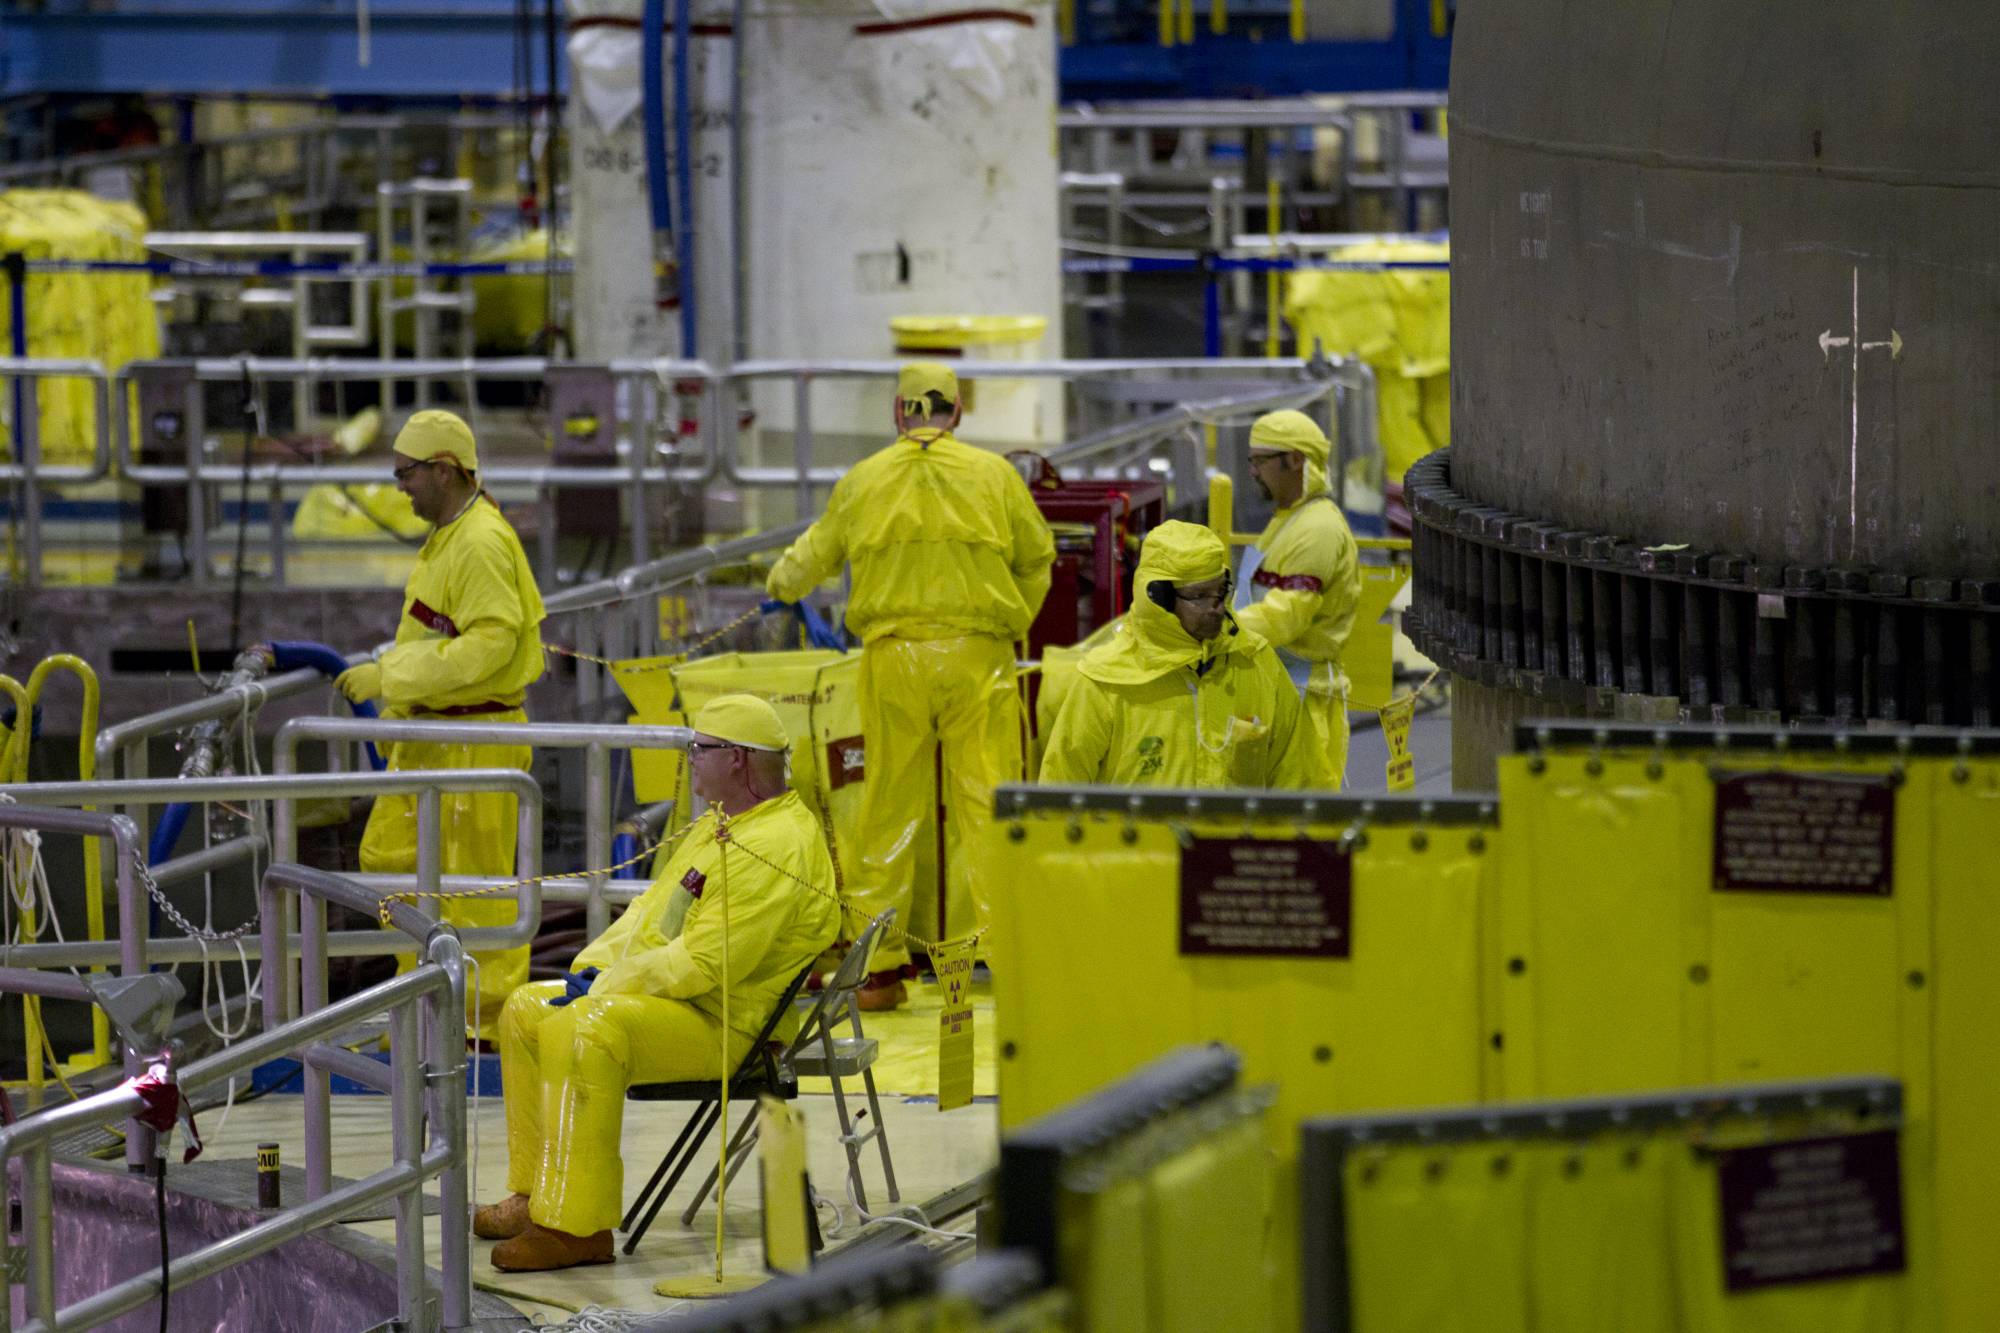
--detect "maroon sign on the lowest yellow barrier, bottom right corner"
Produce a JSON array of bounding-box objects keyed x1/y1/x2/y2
[{"x1": 1716, "y1": 1129, "x2": 1904, "y2": 1291}]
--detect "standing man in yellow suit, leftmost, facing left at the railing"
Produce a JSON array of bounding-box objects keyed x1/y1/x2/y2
[{"x1": 334, "y1": 410, "x2": 542, "y2": 1037}]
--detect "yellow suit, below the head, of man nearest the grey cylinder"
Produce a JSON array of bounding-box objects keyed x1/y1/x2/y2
[{"x1": 1236, "y1": 490, "x2": 1362, "y2": 789}]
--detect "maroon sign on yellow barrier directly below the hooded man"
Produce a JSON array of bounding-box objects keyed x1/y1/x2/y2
[{"x1": 1180, "y1": 839, "x2": 1354, "y2": 959}]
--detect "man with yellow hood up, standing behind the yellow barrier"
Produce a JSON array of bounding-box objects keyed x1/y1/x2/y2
[{"x1": 1042, "y1": 522, "x2": 1326, "y2": 791}]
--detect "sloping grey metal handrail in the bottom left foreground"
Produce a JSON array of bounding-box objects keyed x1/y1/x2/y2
[{"x1": 0, "y1": 896, "x2": 472, "y2": 1333}]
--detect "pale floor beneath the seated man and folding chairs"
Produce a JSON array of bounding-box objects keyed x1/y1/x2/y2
[{"x1": 204, "y1": 1095, "x2": 1000, "y2": 1321}]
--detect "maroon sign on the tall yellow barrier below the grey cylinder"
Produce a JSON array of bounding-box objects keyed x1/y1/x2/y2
[{"x1": 1714, "y1": 771, "x2": 1896, "y2": 895}]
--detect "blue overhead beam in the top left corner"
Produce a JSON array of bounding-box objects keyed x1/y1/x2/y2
[{"x1": 0, "y1": 0, "x2": 564, "y2": 100}]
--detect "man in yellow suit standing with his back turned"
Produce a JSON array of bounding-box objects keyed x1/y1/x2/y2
[{"x1": 764, "y1": 362, "x2": 1056, "y2": 1009}]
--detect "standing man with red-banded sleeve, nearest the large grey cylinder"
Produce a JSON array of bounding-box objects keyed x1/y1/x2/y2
[{"x1": 1236, "y1": 412, "x2": 1362, "y2": 789}]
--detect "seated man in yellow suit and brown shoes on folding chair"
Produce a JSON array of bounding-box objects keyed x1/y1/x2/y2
[{"x1": 472, "y1": 695, "x2": 840, "y2": 1271}]
